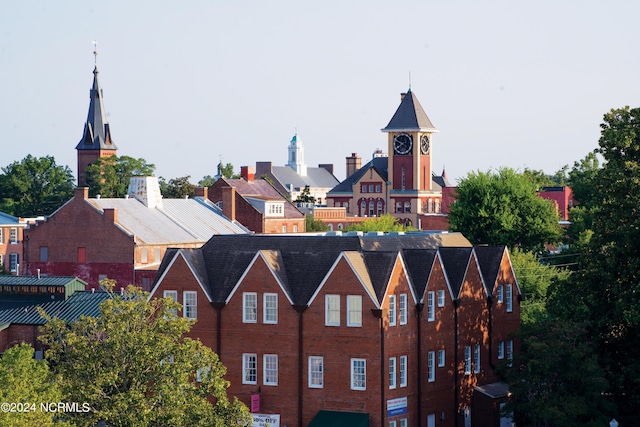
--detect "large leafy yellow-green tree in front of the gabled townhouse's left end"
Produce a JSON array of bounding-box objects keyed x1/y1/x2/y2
[{"x1": 41, "y1": 280, "x2": 249, "y2": 426}]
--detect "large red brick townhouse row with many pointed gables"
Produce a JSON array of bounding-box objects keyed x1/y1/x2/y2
[{"x1": 151, "y1": 233, "x2": 520, "y2": 427}]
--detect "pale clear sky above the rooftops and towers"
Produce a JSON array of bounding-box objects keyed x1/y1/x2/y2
[{"x1": 0, "y1": 0, "x2": 640, "y2": 184}]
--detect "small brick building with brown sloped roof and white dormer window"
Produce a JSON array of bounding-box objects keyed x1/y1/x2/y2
[{"x1": 205, "y1": 166, "x2": 305, "y2": 234}]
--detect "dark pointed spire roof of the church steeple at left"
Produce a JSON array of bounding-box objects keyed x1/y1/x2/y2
[{"x1": 76, "y1": 67, "x2": 118, "y2": 150}]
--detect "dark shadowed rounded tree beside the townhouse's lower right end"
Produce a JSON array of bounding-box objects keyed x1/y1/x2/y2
[{"x1": 498, "y1": 320, "x2": 615, "y2": 427}]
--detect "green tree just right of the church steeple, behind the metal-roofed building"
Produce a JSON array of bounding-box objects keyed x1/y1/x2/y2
[{"x1": 86, "y1": 156, "x2": 156, "y2": 198}]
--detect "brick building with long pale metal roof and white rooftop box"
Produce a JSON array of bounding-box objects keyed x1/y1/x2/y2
[{"x1": 24, "y1": 177, "x2": 248, "y2": 290}]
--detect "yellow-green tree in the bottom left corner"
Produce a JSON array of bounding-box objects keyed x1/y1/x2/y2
[{"x1": 0, "y1": 343, "x2": 62, "y2": 427}]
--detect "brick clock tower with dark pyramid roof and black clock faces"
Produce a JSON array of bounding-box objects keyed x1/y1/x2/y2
[{"x1": 382, "y1": 89, "x2": 441, "y2": 226}]
